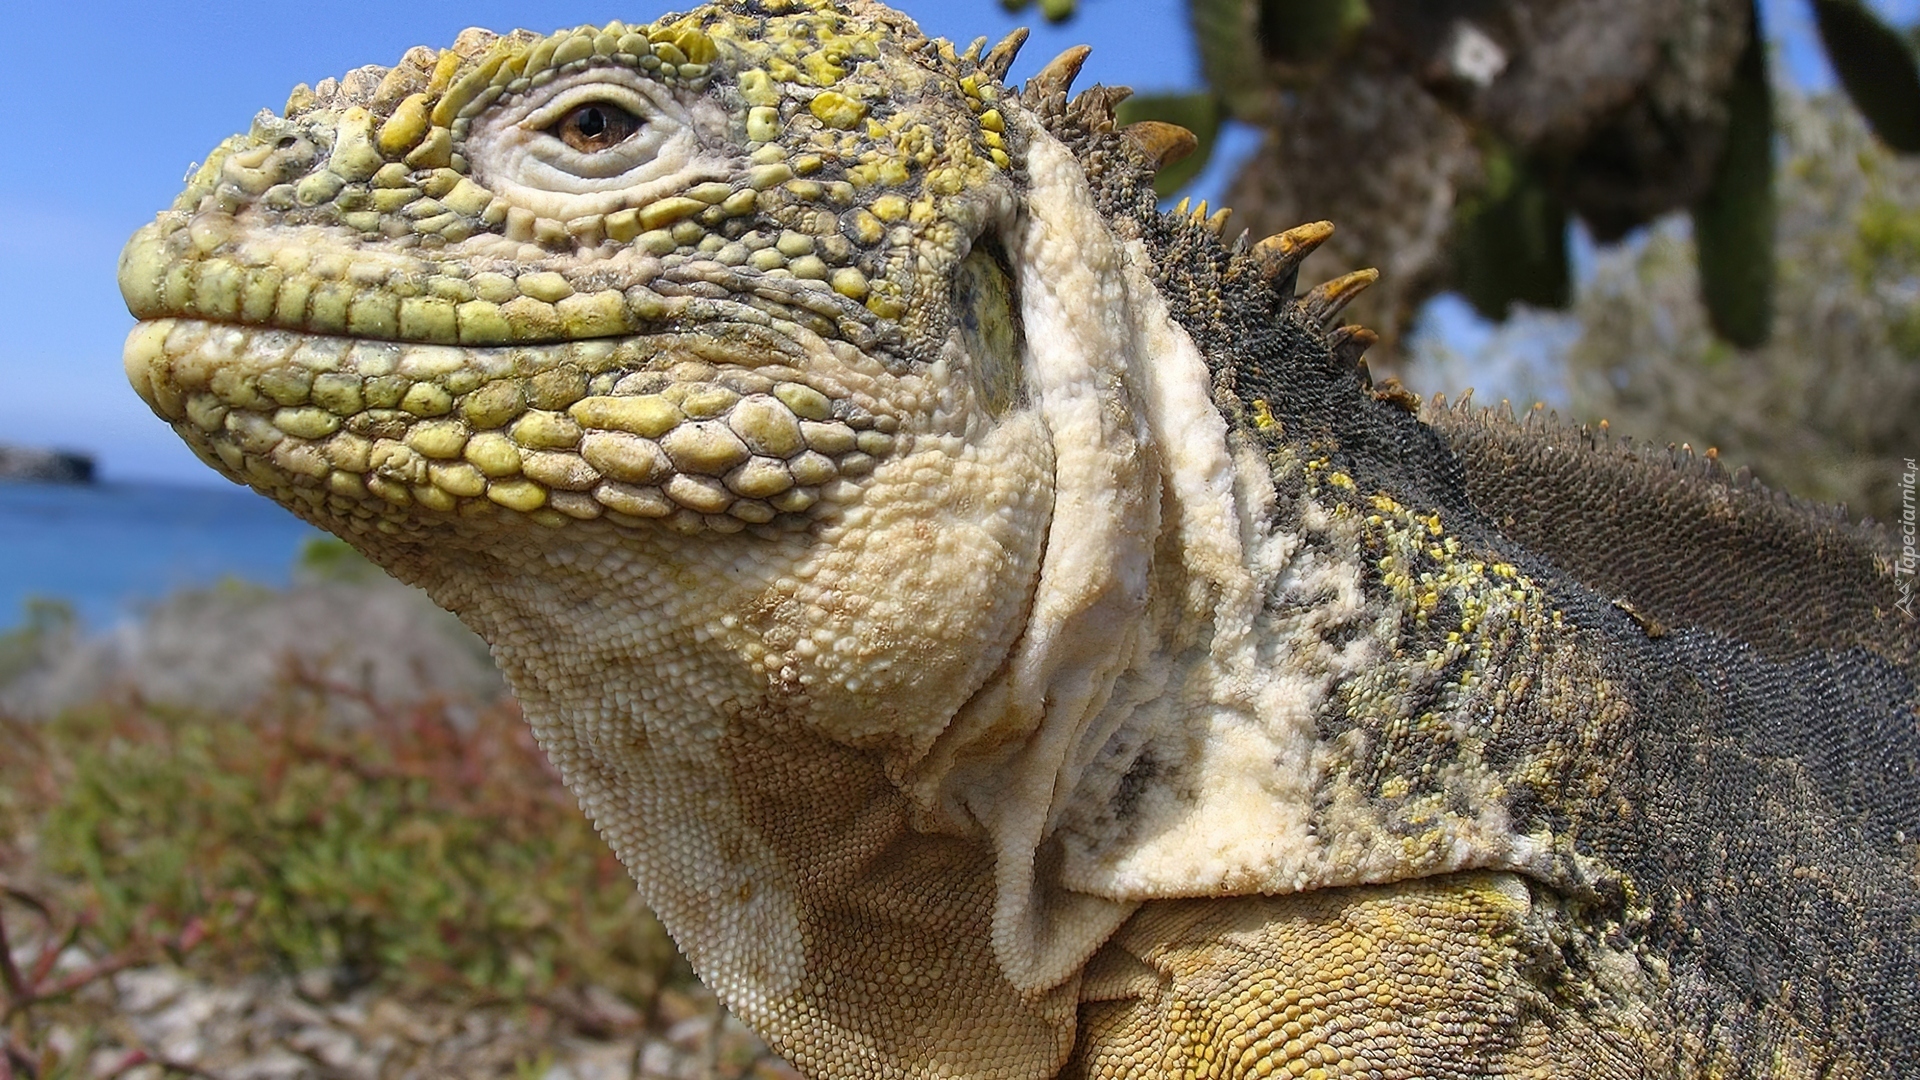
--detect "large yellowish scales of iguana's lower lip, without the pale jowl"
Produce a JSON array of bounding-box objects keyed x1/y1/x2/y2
[{"x1": 125, "y1": 319, "x2": 899, "y2": 534}]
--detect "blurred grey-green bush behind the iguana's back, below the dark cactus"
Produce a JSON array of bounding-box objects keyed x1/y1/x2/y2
[{"x1": 1409, "y1": 94, "x2": 1920, "y2": 521}]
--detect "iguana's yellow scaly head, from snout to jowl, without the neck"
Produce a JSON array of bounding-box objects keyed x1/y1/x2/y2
[{"x1": 121, "y1": 0, "x2": 1048, "y2": 772}]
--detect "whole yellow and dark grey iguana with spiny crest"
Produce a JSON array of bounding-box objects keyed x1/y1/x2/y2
[{"x1": 119, "y1": 0, "x2": 1920, "y2": 1078}]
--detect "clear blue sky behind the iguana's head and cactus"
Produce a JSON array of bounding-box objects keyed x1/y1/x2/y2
[{"x1": 0, "y1": 0, "x2": 1920, "y2": 482}]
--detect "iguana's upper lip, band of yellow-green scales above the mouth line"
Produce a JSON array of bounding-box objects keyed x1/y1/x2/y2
[{"x1": 119, "y1": 212, "x2": 883, "y2": 352}]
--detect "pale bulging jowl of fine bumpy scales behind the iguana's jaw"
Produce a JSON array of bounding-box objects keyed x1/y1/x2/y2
[{"x1": 760, "y1": 415, "x2": 1052, "y2": 767}]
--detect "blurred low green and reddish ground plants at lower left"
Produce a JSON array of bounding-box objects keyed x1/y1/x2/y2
[{"x1": 0, "y1": 676, "x2": 693, "y2": 1076}]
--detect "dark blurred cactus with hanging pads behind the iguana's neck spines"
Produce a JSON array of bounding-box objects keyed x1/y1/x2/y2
[{"x1": 1002, "y1": 0, "x2": 1920, "y2": 353}]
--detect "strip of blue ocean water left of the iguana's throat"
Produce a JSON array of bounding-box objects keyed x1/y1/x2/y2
[{"x1": 0, "y1": 474, "x2": 321, "y2": 630}]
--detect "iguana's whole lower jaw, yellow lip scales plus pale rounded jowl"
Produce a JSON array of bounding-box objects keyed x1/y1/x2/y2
[{"x1": 127, "y1": 297, "x2": 1052, "y2": 734}]
